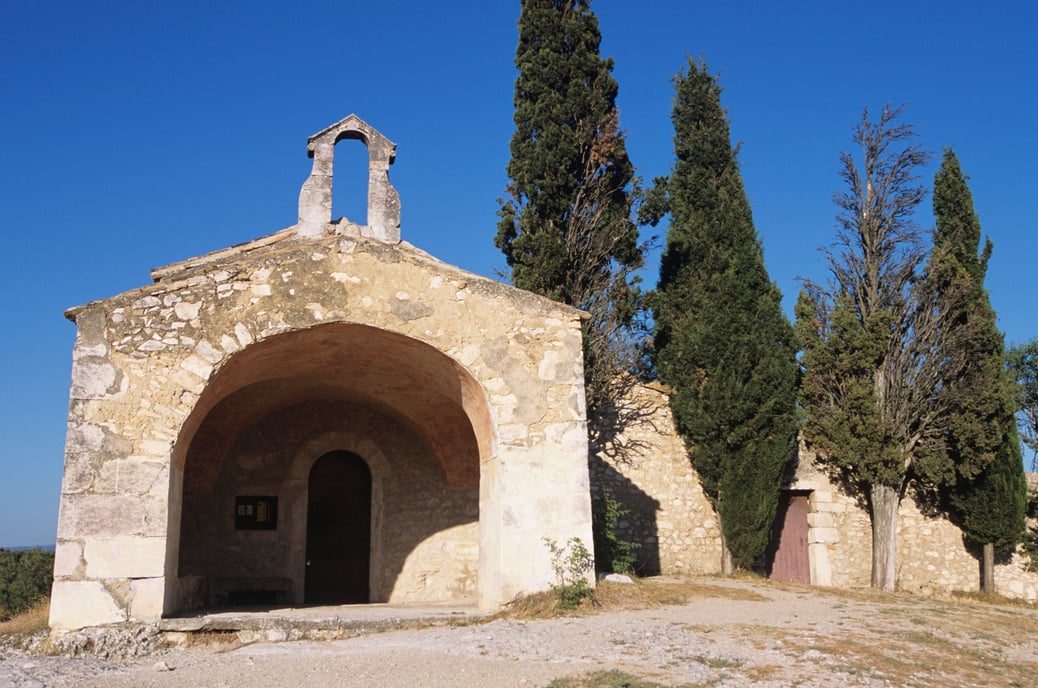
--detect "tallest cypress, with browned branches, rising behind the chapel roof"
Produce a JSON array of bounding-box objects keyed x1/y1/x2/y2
[{"x1": 494, "y1": 0, "x2": 643, "y2": 419}]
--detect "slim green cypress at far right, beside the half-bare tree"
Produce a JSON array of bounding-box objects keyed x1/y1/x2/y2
[{"x1": 927, "y1": 149, "x2": 1027, "y2": 591}]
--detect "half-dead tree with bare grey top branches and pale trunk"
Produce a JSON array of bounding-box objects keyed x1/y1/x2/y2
[{"x1": 798, "y1": 105, "x2": 968, "y2": 590}]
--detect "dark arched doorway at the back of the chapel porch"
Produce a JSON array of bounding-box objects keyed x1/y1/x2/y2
[{"x1": 305, "y1": 451, "x2": 372, "y2": 604}]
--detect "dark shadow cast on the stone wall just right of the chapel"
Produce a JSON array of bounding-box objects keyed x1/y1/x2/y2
[{"x1": 589, "y1": 455, "x2": 660, "y2": 576}]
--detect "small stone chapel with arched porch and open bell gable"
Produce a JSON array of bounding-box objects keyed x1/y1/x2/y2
[{"x1": 51, "y1": 115, "x2": 592, "y2": 629}]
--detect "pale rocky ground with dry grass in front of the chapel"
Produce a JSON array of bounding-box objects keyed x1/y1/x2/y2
[{"x1": 0, "y1": 579, "x2": 1038, "y2": 688}]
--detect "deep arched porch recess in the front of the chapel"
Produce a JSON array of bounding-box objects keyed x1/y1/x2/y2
[{"x1": 166, "y1": 324, "x2": 492, "y2": 613}]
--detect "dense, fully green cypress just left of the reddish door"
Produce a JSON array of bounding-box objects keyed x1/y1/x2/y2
[{"x1": 647, "y1": 59, "x2": 796, "y2": 570}]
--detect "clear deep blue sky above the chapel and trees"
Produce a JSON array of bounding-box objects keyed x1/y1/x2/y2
[{"x1": 0, "y1": 0, "x2": 1038, "y2": 546}]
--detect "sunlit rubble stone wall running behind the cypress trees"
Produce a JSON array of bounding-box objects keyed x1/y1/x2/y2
[{"x1": 590, "y1": 384, "x2": 1038, "y2": 601}]
